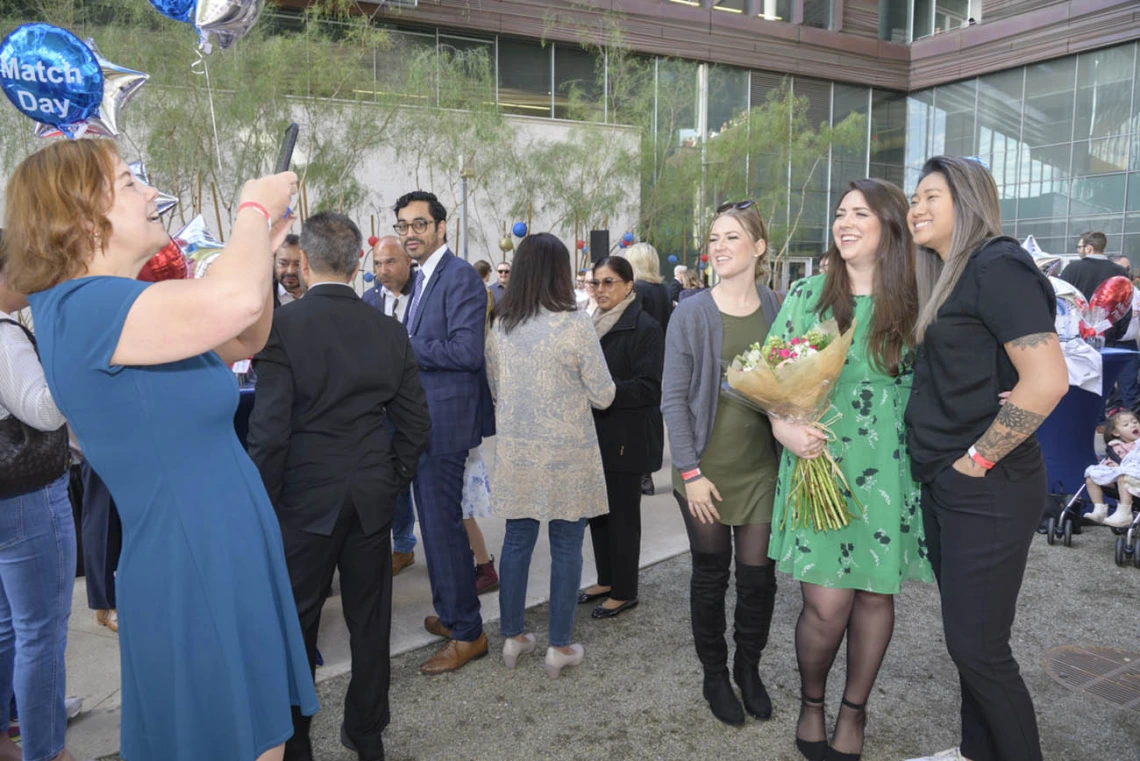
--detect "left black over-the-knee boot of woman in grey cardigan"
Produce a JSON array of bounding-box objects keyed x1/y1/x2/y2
[{"x1": 689, "y1": 551, "x2": 744, "y2": 725}]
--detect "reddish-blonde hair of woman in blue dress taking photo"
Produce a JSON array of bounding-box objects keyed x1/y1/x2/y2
[{"x1": 3, "y1": 140, "x2": 119, "y2": 293}]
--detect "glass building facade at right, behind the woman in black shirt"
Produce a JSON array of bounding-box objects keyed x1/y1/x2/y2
[{"x1": 905, "y1": 42, "x2": 1140, "y2": 258}]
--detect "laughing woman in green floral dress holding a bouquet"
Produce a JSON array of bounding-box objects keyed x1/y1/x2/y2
[{"x1": 768, "y1": 179, "x2": 934, "y2": 761}]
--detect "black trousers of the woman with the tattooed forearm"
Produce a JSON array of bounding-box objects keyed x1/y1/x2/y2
[{"x1": 922, "y1": 464, "x2": 1047, "y2": 761}]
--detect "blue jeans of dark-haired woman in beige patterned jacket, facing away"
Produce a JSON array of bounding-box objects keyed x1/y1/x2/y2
[{"x1": 499, "y1": 518, "x2": 586, "y2": 647}]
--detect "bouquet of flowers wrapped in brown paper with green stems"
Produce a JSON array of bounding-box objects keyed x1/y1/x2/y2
[{"x1": 727, "y1": 320, "x2": 855, "y2": 531}]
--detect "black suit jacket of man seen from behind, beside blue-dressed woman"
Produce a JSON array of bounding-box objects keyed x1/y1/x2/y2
[{"x1": 250, "y1": 284, "x2": 431, "y2": 535}]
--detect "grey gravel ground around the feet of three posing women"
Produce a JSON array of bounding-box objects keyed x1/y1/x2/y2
[{"x1": 93, "y1": 519, "x2": 1140, "y2": 761}]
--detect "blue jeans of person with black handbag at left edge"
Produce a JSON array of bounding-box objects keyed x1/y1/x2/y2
[{"x1": 0, "y1": 475, "x2": 75, "y2": 761}]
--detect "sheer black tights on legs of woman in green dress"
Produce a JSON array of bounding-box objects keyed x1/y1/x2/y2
[{"x1": 796, "y1": 583, "x2": 895, "y2": 753}]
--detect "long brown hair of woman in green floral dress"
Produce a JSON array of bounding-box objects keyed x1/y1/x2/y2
[{"x1": 815, "y1": 178, "x2": 919, "y2": 376}]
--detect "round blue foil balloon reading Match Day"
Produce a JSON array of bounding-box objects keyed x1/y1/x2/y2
[{"x1": 0, "y1": 23, "x2": 103, "y2": 138}]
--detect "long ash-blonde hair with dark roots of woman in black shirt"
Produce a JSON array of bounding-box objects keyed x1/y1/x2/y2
[{"x1": 914, "y1": 156, "x2": 1001, "y2": 343}]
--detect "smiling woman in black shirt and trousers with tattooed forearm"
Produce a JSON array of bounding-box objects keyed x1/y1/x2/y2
[{"x1": 906, "y1": 156, "x2": 1068, "y2": 761}]
